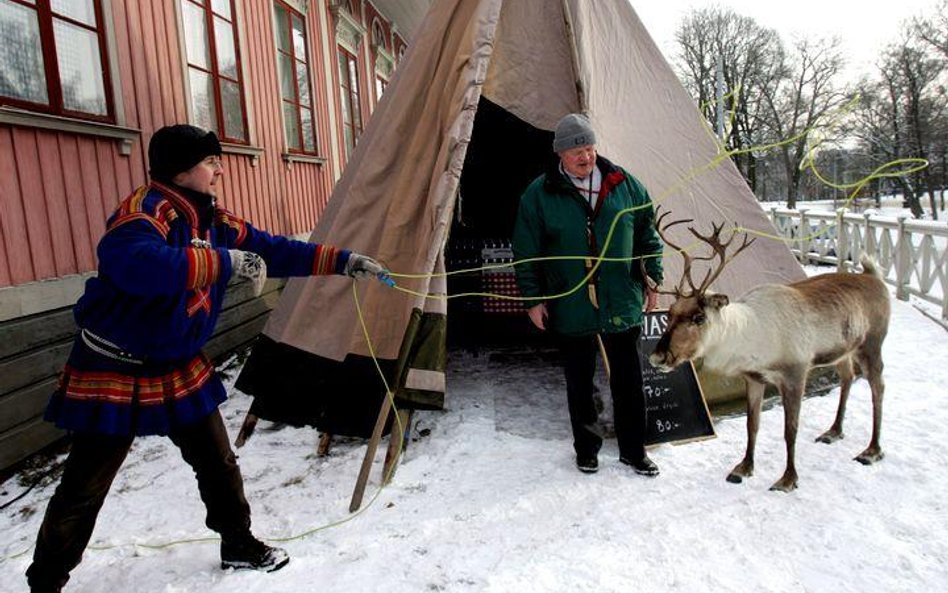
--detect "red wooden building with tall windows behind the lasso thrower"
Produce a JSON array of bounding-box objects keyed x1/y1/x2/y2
[{"x1": 0, "y1": 0, "x2": 431, "y2": 468}]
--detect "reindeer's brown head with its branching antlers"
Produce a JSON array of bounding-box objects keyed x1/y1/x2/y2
[{"x1": 646, "y1": 208, "x2": 754, "y2": 372}]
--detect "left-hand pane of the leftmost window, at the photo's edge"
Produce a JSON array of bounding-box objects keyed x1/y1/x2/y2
[{"x1": 0, "y1": 0, "x2": 49, "y2": 104}]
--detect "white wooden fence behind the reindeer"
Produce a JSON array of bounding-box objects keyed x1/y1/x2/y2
[{"x1": 770, "y1": 208, "x2": 948, "y2": 320}]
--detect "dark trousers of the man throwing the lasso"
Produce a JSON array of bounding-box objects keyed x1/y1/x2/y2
[{"x1": 26, "y1": 410, "x2": 250, "y2": 589}]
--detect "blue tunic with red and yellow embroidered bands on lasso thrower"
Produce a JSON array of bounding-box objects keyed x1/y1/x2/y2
[{"x1": 46, "y1": 182, "x2": 349, "y2": 435}]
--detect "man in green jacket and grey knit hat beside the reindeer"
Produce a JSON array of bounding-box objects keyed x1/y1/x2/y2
[{"x1": 513, "y1": 113, "x2": 662, "y2": 476}]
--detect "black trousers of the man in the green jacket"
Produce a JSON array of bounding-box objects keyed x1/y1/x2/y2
[{"x1": 560, "y1": 327, "x2": 646, "y2": 461}]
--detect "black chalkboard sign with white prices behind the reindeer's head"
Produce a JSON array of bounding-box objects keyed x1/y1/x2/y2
[{"x1": 639, "y1": 311, "x2": 716, "y2": 445}]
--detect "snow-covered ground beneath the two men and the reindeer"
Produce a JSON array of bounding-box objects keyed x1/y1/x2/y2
[{"x1": 0, "y1": 276, "x2": 948, "y2": 593}]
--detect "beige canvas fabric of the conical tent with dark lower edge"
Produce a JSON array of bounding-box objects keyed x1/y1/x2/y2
[{"x1": 237, "y1": 0, "x2": 804, "y2": 434}]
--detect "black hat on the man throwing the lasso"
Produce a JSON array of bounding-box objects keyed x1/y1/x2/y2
[{"x1": 148, "y1": 124, "x2": 221, "y2": 183}]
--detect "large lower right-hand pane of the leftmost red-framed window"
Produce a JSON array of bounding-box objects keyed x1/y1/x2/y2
[{"x1": 53, "y1": 19, "x2": 108, "y2": 115}]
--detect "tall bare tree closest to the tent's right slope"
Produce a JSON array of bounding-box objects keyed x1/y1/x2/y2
[{"x1": 675, "y1": 7, "x2": 785, "y2": 191}]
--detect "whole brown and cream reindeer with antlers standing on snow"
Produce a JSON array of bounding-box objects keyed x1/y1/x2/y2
[{"x1": 649, "y1": 211, "x2": 889, "y2": 492}]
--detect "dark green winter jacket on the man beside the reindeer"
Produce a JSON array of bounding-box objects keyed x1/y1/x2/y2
[{"x1": 513, "y1": 157, "x2": 663, "y2": 336}]
